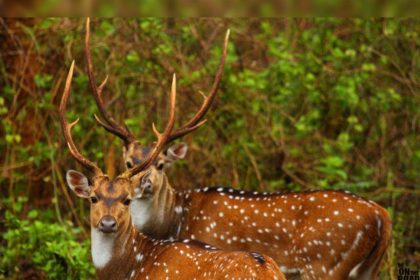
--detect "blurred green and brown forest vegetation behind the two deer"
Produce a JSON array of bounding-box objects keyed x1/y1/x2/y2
[{"x1": 0, "y1": 18, "x2": 420, "y2": 279}]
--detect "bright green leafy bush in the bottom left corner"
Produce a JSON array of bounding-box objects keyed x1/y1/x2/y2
[{"x1": 0, "y1": 197, "x2": 94, "y2": 279}]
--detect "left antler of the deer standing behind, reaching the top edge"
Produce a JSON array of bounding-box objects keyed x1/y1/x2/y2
[{"x1": 85, "y1": 18, "x2": 136, "y2": 144}]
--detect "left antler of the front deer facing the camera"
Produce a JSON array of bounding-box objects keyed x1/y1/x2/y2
[{"x1": 59, "y1": 60, "x2": 103, "y2": 176}]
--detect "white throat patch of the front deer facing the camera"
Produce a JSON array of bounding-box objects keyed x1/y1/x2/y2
[{"x1": 91, "y1": 228, "x2": 115, "y2": 268}]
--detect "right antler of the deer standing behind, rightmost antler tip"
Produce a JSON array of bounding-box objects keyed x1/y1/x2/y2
[{"x1": 168, "y1": 29, "x2": 230, "y2": 142}]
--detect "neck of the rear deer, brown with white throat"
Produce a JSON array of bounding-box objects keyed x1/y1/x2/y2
[{"x1": 131, "y1": 174, "x2": 178, "y2": 239}]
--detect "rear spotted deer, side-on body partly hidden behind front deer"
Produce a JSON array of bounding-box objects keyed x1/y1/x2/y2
[{"x1": 85, "y1": 18, "x2": 391, "y2": 279}]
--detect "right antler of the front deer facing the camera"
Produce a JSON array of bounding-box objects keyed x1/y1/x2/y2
[{"x1": 122, "y1": 74, "x2": 176, "y2": 178}]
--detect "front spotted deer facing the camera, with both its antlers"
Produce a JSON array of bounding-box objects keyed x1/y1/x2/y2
[{"x1": 59, "y1": 61, "x2": 285, "y2": 280}]
